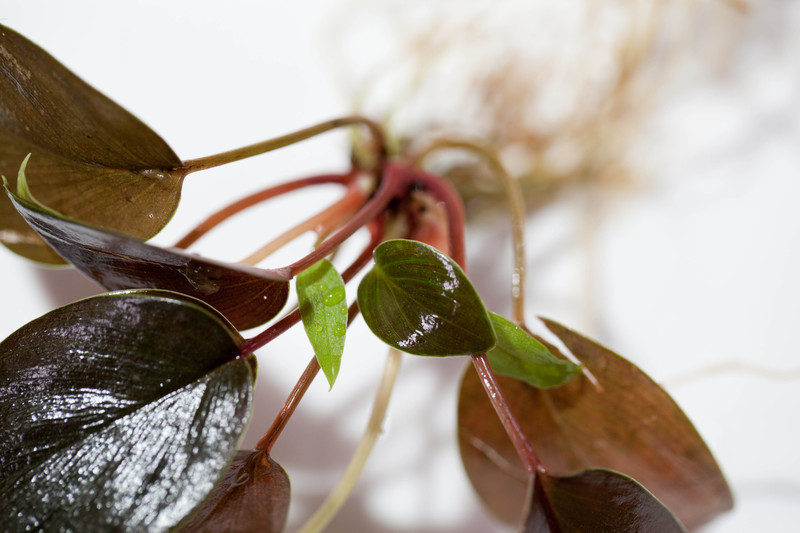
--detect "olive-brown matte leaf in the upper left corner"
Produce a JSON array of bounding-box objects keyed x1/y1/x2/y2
[{"x1": 0, "y1": 26, "x2": 185, "y2": 263}]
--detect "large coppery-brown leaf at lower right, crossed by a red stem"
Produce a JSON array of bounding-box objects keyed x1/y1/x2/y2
[{"x1": 458, "y1": 321, "x2": 732, "y2": 528}]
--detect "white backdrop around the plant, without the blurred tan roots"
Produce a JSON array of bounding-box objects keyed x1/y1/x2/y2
[{"x1": 0, "y1": 0, "x2": 800, "y2": 533}]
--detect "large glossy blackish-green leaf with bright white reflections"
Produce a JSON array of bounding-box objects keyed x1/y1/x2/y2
[{"x1": 0, "y1": 290, "x2": 255, "y2": 531}]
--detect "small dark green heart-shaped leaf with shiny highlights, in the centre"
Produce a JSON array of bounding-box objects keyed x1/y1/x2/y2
[{"x1": 358, "y1": 239, "x2": 495, "y2": 356}]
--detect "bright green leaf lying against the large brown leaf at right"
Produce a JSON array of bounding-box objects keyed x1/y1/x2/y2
[{"x1": 486, "y1": 312, "x2": 581, "y2": 388}]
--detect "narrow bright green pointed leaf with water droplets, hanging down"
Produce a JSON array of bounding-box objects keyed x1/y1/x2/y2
[{"x1": 296, "y1": 259, "x2": 347, "y2": 387}]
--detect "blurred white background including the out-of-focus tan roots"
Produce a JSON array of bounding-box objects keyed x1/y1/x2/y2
[{"x1": 0, "y1": 0, "x2": 800, "y2": 533}]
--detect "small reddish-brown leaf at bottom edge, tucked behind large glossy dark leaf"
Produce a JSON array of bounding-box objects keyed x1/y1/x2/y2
[{"x1": 179, "y1": 450, "x2": 290, "y2": 533}]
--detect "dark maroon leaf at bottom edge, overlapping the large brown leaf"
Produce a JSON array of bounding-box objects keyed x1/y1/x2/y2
[{"x1": 522, "y1": 469, "x2": 686, "y2": 533}]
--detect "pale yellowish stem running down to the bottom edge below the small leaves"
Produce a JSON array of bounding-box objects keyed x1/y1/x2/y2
[{"x1": 299, "y1": 349, "x2": 402, "y2": 533}]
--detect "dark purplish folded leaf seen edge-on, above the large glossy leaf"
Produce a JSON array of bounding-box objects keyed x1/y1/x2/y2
[{"x1": 7, "y1": 185, "x2": 289, "y2": 329}]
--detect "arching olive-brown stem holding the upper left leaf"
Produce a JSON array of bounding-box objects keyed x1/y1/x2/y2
[{"x1": 181, "y1": 116, "x2": 386, "y2": 174}]
